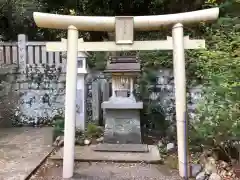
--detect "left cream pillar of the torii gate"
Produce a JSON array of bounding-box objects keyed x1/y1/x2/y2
[{"x1": 63, "y1": 25, "x2": 78, "y2": 178}]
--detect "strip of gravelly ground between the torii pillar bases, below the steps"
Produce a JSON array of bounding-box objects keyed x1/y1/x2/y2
[{"x1": 30, "y1": 160, "x2": 181, "y2": 180}]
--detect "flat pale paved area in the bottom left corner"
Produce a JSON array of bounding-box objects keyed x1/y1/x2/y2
[{"x1": 0, "y1": 127, "x2": 53, "y2": 180}]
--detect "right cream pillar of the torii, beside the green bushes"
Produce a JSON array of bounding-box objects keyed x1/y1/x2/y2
[{"x1": 172, "y1": 23, "x2": 190, "y2": 178}]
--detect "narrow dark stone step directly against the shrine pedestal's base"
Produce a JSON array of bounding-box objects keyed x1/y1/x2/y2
[{"x1": 93, "y1": 143, "x2": 149, "y2": 153}]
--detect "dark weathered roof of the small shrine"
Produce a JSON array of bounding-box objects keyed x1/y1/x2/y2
[{"x1": 104, "y1": 56, "x2": 141, "y2": 72}]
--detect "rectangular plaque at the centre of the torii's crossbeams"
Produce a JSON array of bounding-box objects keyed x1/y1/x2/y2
[{"x1": 115, "y1": 16, "x2": 134, "y2": 44}]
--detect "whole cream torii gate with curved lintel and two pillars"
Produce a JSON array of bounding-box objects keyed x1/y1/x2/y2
[{"x1": 33, "y1": 8, "x2": 219, "y2": 178}]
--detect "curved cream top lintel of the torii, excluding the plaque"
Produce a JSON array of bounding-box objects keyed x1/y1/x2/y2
[{"x1": 33, "y1": 8, "x2": 219, "y2": 31}]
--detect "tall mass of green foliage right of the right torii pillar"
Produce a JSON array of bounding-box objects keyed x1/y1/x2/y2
[{"x1": 188, "y1": 8, "x2": 240, "y2": 145}]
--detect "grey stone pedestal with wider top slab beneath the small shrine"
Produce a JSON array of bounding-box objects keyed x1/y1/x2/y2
[{"x1": 102, "y1": 97, "x2": 143, "y2": 144}]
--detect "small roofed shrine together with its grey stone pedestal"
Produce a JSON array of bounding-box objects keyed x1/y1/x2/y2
[{"x1": 102, "y1": 57, "x2": 143, "y2": 144}]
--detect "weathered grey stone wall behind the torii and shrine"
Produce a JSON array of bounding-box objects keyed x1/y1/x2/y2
[{"x1": 0, "y1": 65, "x2": 201, "y2": 126}]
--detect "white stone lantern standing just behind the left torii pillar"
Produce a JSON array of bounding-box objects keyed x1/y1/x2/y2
[{"x1": 76, "y1": 52, "x2": 88, "y2": 131}]
